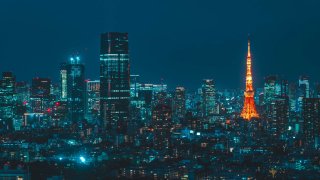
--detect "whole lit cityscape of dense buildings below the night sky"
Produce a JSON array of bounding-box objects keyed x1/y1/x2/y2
[{"x1": 0, "y1": 32, "x2": 320, "y2": 179}]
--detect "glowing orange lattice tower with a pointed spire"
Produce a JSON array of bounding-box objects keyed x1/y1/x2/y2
[{"x1": 241, "y1": 38, "x2": 259, "y2": 120}]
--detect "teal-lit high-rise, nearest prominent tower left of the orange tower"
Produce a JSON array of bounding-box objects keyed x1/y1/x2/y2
[{"x1": 201, "y1": 79, "x2": 216, "y2": 116}]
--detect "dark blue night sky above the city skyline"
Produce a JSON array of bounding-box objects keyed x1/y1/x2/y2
[{"x1": 0, "y1": 0, "x2": 320, "y2": 89}]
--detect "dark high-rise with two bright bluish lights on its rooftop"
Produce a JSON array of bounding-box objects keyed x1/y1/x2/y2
[{"x1": 65, "y1": 56, "x2": 86, "y2": 122}]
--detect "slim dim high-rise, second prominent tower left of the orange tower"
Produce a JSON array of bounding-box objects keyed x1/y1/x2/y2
[{"x1": 173, "y1": 87, "x2": 186, "y2": 123}]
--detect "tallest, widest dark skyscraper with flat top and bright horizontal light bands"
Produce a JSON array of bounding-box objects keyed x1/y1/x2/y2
[{"x1": 100, "y1": 32, "x2": 130, "y2": 134}]
